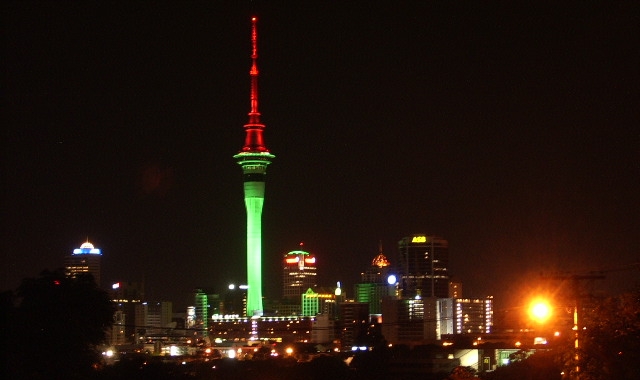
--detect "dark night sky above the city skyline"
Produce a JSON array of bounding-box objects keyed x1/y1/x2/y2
[{"x1": 0, "y1": 1, "x2": 640, "y2": 308}]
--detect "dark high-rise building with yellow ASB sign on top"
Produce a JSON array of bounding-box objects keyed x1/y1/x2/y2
[{"x1": 398, "y1": 234, "x2": 449, "y2": 298}]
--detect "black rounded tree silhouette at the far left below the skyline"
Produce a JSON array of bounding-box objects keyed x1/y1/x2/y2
[{"x1": 3, "y1": 270, "x2": 114, "y2": 380}]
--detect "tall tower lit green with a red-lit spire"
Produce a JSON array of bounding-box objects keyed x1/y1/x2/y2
[{"x1": 233, "y1": 17, "x2": 275, "y2": 317}]
